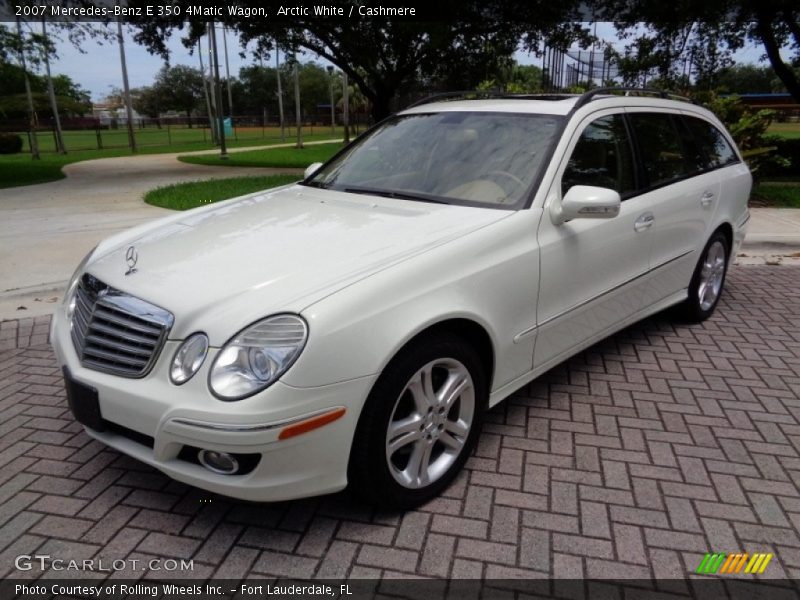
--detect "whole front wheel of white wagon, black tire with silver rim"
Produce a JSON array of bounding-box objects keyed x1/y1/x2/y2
[{"x1": 348, "y1": 334, "x2": 488, "y2": 509}]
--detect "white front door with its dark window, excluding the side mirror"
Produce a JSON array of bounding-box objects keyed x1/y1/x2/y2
[{"x1": 533, "y1": 110, "x2": 654, "y2": 368}]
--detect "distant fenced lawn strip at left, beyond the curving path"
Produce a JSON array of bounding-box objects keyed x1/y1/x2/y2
[{"x1": 0, "y1": 127, "x2": 340, "y2": 188}]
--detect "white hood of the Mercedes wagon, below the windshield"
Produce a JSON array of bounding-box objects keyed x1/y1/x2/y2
[{"x1": 87, "y1": 185, "x2": 512, "y2": 345}]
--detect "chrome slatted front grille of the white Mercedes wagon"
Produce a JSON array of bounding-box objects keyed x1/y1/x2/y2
[{"x1": 70, "y1": 273, "x2": 174, "y2": 377}]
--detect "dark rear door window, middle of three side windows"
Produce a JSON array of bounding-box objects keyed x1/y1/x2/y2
[{"x1": 630, "y1": 113, "x2": 693, "y2": 187}]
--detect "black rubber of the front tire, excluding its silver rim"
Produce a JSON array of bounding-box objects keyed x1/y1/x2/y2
[{"x1": 349, "y1": 335, "x2": 488, "y2": 508}]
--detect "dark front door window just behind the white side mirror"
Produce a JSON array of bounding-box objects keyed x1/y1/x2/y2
[{"x1": 561, "y1": 115, "x2": 634, "y2": 195}]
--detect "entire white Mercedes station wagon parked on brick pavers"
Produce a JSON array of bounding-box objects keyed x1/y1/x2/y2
[{"x1": 51, "y1": 90, "x2": 751, "y2": 507}]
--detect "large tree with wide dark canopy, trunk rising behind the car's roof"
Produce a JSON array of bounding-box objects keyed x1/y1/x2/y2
[{"x1": 129, "y1": 0, "x2": 580, "y2": 120}]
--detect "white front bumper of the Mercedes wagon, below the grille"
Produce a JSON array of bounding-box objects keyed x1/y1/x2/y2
[{"x1": 50, "y1": 307, "x2": 375, "y2": 501}]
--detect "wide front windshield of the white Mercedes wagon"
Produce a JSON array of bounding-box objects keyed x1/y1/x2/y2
[{"x1": 305, "y1": 112, "x2": 560, "y2": 208}]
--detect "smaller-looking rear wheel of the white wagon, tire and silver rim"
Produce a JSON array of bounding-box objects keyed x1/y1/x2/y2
[{"x1": 677, "y1": 231, "x2": 730, "y2": 323}]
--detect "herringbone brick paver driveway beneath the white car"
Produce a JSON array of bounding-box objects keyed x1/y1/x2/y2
[{"x1": 0, "y1": 267, "x2": 800, "y2": 584}]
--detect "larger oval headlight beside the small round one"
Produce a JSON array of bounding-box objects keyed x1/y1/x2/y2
[{"x1": 208, "y1": 315, "x2": 308, "y2": 400}]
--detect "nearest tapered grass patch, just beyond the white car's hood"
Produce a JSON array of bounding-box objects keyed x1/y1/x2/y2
[{"x1": 144, "y1": 175, "x2": 299, "y2": 210}]
